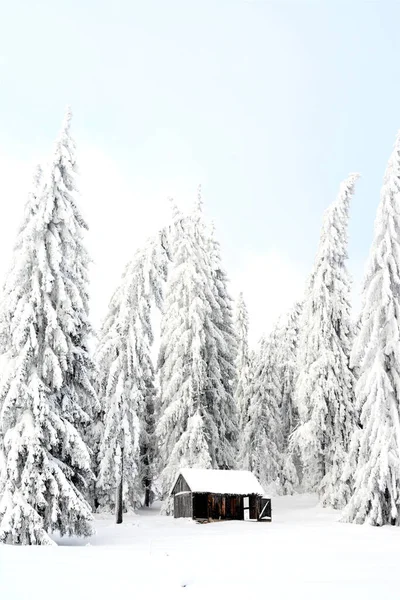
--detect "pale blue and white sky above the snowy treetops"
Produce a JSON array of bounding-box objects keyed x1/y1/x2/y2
[{"x1": 0, "y1": 0, "x2": 400, "y2": 340}]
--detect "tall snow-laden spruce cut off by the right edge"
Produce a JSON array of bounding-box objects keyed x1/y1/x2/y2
[{"x1": 343, "y1": 132, "x2": 400, "y2": 525}]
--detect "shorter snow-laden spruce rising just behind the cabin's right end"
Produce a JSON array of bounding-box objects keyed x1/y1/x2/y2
[{"x1": 240, "y1": 328, "x2": 283, "y2": 493}]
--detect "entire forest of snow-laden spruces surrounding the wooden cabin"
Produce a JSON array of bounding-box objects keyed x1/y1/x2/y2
[{"x1": 0, "y1": 109, "x2": 400, "y2": 545}]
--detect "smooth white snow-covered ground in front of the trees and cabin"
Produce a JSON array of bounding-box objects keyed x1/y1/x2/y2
[{"x1": 0, "y1": 495, "x2": 400, "y2": 600}]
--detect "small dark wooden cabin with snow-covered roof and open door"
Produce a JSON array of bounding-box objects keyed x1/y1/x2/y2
[{"x1": 171, "y1": 469, "x2": 272, "y2": 521}]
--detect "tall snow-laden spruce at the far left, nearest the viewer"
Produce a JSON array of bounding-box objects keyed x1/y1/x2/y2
[{"x1": 0, "y1": 106, "x2": 95, "y2": 544}]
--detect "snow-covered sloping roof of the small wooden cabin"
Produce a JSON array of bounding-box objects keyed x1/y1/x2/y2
[{"x1": 177, "y1": 469, "x2": 265, "y2": 496}]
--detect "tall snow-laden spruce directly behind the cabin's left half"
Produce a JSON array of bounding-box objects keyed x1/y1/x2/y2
[{"x1": 156, "y1": 202, "x2": 232, "y2": 510}]
